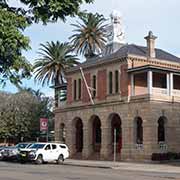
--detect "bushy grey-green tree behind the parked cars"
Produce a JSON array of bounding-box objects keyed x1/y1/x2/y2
[{"x1": 0, "y1": 90, "x2": 53, "y2": 141}]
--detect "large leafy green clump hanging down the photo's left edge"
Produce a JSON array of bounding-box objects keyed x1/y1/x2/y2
[{"x1": 0, "y1": 9, "x2": 31, "y2": 84}]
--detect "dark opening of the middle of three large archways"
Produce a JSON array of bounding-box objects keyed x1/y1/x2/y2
[{"x1": 92, "y1": 116, "x2": 101, "y2": 152}]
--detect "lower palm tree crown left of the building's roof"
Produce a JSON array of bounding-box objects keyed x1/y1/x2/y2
[{"x1": 34, "y1": 41, "x2": 78, "y2": 86}]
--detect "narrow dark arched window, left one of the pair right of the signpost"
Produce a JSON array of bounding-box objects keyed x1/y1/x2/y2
[{"x1": 135, "y1": 117, "x2": 143, "y2": 144}]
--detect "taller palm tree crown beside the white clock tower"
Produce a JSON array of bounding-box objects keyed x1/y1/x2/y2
[{"x1": 70, "y1": 13, "x2": 106, "y2": 57}]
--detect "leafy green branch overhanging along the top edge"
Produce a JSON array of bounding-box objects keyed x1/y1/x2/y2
[{"x1": 0, "y1": 0, "x2": 94, "y2": 23}]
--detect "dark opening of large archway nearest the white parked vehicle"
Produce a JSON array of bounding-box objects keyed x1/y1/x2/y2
[{"x1": 75, "y1": 118, "x2": 83, "y2": 152}]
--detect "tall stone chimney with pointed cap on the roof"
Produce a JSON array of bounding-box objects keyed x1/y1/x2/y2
[{"x1": 144, "y1": 31, "x2": 157, "y2": 58}]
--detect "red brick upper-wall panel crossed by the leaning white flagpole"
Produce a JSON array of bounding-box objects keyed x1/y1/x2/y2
[{"x1": 82, "y1": 73, "x2": 91, "y2": 102}]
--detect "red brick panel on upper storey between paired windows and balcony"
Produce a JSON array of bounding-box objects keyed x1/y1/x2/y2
[{"x1": 120, "y1": 64, "x2": 130, "y2": 96}]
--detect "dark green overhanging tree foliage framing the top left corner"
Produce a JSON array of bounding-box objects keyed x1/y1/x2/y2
[{"x1": 0, "y1": 0, "x2": 93, "y2": 84}]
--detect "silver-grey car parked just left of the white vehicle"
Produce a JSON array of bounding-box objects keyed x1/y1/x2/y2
[{"x1": 2, "y1": 143, "x2": 32, "y2": 160}]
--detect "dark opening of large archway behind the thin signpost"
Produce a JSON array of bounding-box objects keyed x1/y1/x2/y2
[{"x1": 110, "y1": 113, "x2": 122, "y2": 153}]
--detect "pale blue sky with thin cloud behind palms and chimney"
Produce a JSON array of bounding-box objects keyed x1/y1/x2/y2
[{"x1": 0, "y1": 0, "x2": 180, "y2": 96}]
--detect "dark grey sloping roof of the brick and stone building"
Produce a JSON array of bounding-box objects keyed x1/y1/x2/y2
[{"x1": 68, "y1": 44, "x2": 180, "y2": 72}]
